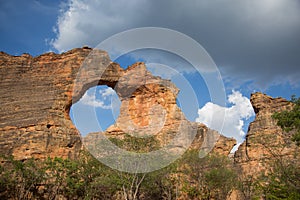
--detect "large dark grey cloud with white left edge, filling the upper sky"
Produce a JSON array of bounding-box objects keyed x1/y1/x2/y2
[{"x1": 52, "y1": 0, "x2": 300, "y2": 87}]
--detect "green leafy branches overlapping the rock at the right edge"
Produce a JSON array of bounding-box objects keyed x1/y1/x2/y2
[{"x1": 273, "y1": 96, "x2": 300, "y2": 145}]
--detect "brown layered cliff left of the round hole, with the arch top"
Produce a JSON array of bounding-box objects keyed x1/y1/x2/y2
[{"x1": 0, "y1": 48, "x2": 122, "y2": 159}]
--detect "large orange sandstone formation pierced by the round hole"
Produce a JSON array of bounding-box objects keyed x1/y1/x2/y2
[{"x1": 0, "y1": 48, "x2": 234, "y2": 160}]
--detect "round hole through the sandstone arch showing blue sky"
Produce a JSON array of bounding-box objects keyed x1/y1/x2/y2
[{"x1": 70, "y1": 85, "x2": 121, "y2": 136}]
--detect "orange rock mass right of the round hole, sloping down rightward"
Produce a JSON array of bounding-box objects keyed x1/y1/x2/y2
[{"x1": 84, "y1": 63, "x2": 236, "y2": 157}]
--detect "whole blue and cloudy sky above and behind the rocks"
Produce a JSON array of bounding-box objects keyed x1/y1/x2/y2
[{"x1": 0, "y1": 0, "x2": 300, "y2": 147}]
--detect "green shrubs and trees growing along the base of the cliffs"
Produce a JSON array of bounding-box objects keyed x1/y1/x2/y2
[{"x1": 0, "y1": 97, "x2": 300, "y2": 200}]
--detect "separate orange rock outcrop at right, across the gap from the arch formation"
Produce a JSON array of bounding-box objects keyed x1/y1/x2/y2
[{"x1": 234, "y1": 93, "x2": 297, "y2": 177}]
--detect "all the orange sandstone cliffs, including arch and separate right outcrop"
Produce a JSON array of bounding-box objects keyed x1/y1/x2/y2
[{"x1": 0, "y1": 48, "x2": 299, "y2": 199}]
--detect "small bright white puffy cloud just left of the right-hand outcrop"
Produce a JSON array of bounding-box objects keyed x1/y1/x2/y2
[{"x1": 196, "y1": 91, "x2": 255, "y2": 143}]
